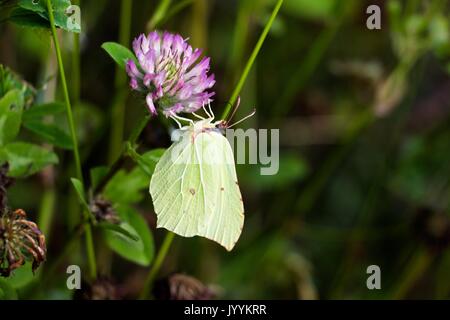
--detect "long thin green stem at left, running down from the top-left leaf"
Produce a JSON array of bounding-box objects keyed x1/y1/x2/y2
[{"x1": 47, "y1": 0, "x2": 97, "y2": 278}]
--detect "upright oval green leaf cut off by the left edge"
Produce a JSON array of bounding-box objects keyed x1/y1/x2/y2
[{"x1": 0, "y1": 89, "x2": 23, "y2": 146}]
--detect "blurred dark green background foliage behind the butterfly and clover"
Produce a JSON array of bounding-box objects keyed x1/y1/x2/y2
[{"x1": 0, "y1": 0, "x2": 450, "y2": 299}]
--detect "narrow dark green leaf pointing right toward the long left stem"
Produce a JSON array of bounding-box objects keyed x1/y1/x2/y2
[{"x1": 23, "y1": 121, "x2": 73, "y2": 149}]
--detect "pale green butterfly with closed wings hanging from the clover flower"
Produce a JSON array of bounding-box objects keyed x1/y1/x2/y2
[{"x1": 150, "y1": 104, "x2": 250, "y2": 251}]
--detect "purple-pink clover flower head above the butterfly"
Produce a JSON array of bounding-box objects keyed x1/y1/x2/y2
[{"x1": 126, "y1": 31, "x2": 215, "y2": 116}]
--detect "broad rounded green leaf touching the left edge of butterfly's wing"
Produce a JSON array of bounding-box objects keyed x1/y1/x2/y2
[{"x1": 103, "y1": 168, "x2": 150, "y2": 204}]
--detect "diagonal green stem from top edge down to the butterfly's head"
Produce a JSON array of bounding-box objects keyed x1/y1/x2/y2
[{"x1": 222, "y1": 0, "x2": 283, "y2": 119}]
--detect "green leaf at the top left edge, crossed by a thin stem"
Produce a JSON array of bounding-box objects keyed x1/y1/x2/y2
[{"x1": 10, "y1": 0, "x2": 81, "y2": 33}]
